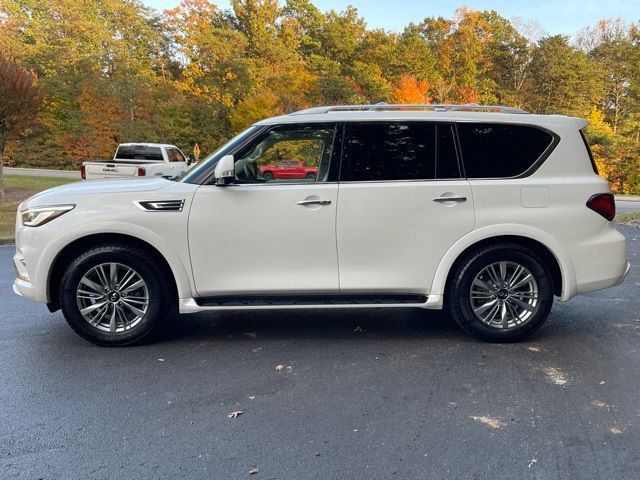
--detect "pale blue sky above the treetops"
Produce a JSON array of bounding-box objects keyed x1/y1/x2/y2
[{"x1": 142, "y1": 0, "x2": 640, "y2": 35}]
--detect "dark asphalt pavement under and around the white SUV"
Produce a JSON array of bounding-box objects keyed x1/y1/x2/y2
[{"x1": 0, "y1": 226, "x2": 640, "y2": 480}]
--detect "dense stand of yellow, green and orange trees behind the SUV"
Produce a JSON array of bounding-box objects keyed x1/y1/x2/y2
[{"x1": 0, "y1": 0, "x2": 640, "y2": 193}]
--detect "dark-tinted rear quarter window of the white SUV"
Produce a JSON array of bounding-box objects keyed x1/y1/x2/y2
[{"x1": 457, "y1": 123, "x2": 554, "y2": 178}]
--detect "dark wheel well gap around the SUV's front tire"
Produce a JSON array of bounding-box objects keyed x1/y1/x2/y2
[{"x1": 46, "y1": 232, "x2": 181, "y2": 312}]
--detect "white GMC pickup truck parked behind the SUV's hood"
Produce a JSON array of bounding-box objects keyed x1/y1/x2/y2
[{"x1": 80, "y1": 143, "x2": 191, "y2": 180}]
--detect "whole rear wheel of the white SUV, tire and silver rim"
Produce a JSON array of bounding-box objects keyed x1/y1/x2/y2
[{"x1": 447, "y1": 243, "x2": 553, "y2": 342}]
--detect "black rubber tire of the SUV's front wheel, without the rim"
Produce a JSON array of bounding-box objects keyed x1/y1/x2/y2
[{"x1": 60, "y1": 244, "x2": 177, "y2": 346}]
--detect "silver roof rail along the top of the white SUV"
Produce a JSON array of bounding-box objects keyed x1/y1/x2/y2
[{"x1": 290, "y1": 103, "x2": 529, "y2": 115}]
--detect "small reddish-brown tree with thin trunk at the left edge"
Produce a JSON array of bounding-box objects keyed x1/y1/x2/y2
[{"x1": 0, "y1": 55, "x2": 40, "y2": 201}]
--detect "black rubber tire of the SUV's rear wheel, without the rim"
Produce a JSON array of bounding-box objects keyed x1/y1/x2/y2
[{"x1": 445, "y1": 243, "x2": 554, "y2": 343}]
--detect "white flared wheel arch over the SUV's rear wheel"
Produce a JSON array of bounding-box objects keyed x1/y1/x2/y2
[{"x1": 429, "y1": 226, "x2": 577, "y2": 308}]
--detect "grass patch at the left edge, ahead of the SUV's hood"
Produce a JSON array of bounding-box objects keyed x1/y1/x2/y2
[{"x1": 0, "y1": 175, "x2": 78, "y2": 237}]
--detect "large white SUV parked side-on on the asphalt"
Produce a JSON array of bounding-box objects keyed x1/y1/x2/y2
[{"x1": 14, "y1": 105, "x2": 629, "y2": 345}]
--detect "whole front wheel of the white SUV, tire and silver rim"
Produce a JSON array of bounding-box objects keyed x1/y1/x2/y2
[{"x1": 60, "y1": 244, "x2": 177, "y2": 346}]
